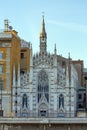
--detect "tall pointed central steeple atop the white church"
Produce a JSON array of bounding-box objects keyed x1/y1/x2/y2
[{"x1": 40, "y1": 15, "x2": 47, "y2": 54}]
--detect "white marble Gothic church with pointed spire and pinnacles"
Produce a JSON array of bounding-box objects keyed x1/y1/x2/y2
[{"x1": 12, "y1": 17, "x2": 78, "y2": 117}]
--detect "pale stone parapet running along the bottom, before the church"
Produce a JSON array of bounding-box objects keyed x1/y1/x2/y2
[{"x1": 0, "y1": 118, "x2": 87, "y2": 124}]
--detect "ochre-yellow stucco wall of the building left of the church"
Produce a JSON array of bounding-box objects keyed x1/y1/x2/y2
[{"x1": 0, "y1": 30, "x2": 20, "y2": 90}]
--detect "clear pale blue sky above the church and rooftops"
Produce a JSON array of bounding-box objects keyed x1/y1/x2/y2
[{"x1": 0, "y1": 0, "x2": 87, "y2": 67}]
